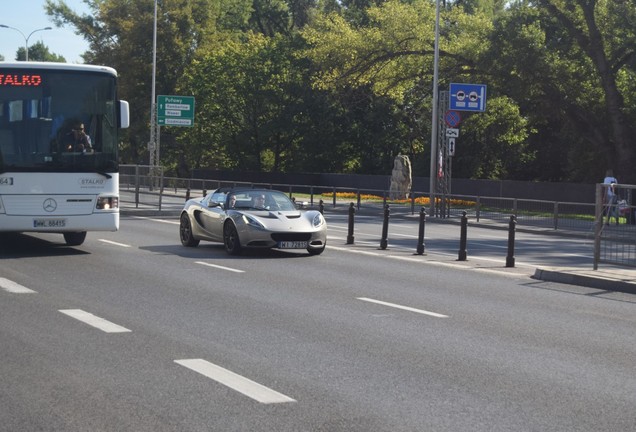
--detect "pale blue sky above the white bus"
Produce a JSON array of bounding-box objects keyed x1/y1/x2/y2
[{"x1": 0, "y1": 0, "x2": 90, "y2": 63}]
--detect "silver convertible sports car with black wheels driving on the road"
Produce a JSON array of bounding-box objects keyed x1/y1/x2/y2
[{"x1": 179, "y1": 188, "x2": 327, "y2": 255}]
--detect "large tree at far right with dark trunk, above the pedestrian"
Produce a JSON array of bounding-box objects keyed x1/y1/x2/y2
[{"x1": 484, "y1": 0, "x2": 636, "y2": 182}]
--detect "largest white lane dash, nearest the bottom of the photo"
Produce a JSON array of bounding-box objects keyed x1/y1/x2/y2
[{"x1": 174, "y1": 359, "x2": 296, "y2": 404}]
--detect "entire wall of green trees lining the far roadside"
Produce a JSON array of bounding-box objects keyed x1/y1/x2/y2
[{"x1": 47, "y1": 0, "x2": 636, "y2": 182}]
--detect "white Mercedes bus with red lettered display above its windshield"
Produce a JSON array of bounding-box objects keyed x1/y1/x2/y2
[{"x1": 0, "y1": 62, "x2": 129, "y2": 246}]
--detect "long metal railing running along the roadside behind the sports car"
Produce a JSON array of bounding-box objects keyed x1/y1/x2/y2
[{"x1": 120, "y1": 165, "x2": 636, "y2": 269}]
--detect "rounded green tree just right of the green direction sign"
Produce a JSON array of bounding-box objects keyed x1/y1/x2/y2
[{"x1": 180, "y1": 33, "x2": 312, "y2": 171}]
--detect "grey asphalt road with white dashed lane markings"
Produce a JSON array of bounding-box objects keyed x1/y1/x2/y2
[{"x1": 0, "y1": 215, "x2": 636, "y2": 432}]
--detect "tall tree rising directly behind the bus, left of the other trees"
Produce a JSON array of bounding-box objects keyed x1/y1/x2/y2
[{"x1": 46, "y1": 0, "x2": 234, "y2": 162}]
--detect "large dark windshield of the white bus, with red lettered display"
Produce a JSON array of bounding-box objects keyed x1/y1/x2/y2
[{"x1": 0, "y1": 63, "x2": 118, "y2": 173}]
